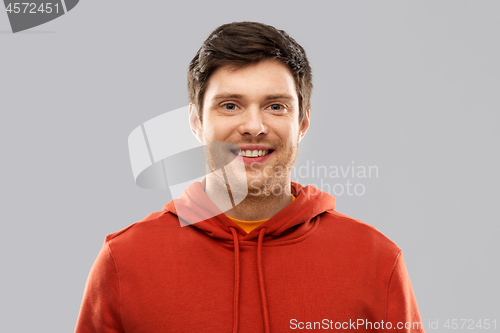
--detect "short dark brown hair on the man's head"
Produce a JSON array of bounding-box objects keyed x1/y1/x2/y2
[{"x1": 188, "y1": 22, "x2": 313, "y2": 123}]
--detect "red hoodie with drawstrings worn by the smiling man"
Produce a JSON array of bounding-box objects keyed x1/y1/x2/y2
[{"x1": 75, "y1": 180, "x2": 424, "y2": 333}]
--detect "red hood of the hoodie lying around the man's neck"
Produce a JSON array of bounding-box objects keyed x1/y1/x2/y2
[{"x1": 163, "y1": 178, "x2": 335, "y2": 242}]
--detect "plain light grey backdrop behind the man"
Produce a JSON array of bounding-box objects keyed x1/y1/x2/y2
[{"x1": 0, "y1": 0, "x2": 500, "y2": 332}]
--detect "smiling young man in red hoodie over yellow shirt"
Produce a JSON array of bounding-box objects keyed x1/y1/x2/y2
[{"x1": 76, "y1": 22, "x2": 423, "y2": 333}]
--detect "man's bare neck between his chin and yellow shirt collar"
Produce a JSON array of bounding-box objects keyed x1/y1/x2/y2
[{"x1": 205, "y1": 177, "x2": 293, "y2": 221}]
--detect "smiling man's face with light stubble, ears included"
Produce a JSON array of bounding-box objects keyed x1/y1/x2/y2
[{"x1": 190, "y1": 60, "x2": 309, "y2": 195}]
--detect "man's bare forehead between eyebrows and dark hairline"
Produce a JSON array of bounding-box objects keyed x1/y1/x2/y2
[{"x1": 204, "y1": 60, "x2": 298, "y2": 102}]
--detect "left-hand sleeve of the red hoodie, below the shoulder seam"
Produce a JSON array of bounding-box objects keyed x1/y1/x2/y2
[{"x1": 75, "y1": 240, "x2": 125, "y2": 333}]
